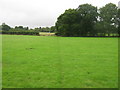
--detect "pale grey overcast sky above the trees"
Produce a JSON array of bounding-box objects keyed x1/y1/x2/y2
[{"x1": 0, "y1": 0, "x2": 119, "y2": 28}]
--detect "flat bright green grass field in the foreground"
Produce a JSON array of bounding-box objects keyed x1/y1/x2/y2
[{"x1": 2, "y1": 35, "x2": 118, "y2": 88}]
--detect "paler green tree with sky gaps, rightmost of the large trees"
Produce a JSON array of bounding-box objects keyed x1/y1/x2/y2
[{"x1": 99, "y1": 3, "x2": 117, "y2": 36}]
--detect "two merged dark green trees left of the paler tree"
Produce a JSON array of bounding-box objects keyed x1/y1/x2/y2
[{"x1": 56, "y1": 4, "x2": 98, "y2": 36}]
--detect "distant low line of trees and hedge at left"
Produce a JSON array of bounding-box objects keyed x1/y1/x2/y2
[{"x1": 0, "y1": 23, "x2": 55, "y2": 35}]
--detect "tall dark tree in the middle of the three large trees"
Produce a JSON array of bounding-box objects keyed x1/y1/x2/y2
[{"x1": 77, "y1": 4, "x2": 98, "y2": 36}]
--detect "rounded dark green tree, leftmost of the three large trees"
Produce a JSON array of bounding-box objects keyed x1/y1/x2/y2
[{"x1": 56, "y1": 9, "x2": 79, "y2": 36}]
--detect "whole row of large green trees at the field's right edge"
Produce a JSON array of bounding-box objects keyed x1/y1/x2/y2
[{"x1": 56, "y1": 3, "x2": 120, "y2": 36}]
